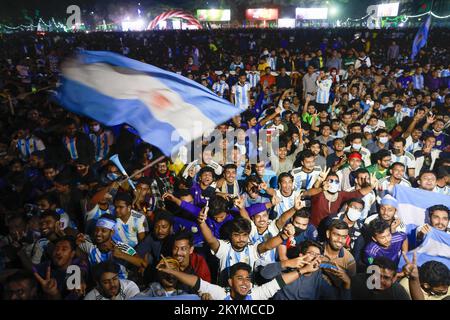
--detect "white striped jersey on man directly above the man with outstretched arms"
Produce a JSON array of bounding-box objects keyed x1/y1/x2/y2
[{"x1": 211, "y1": 239, "x2": 260, "y2": 271}]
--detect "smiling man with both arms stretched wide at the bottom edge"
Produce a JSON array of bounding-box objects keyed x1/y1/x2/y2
[{"x1": 158, "y1": 262, "x2": 301, "y2": 300}]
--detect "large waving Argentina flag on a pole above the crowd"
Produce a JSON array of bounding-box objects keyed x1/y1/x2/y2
[{"x1": 56, "y1": 50, "x2": 240, "y2": 156}]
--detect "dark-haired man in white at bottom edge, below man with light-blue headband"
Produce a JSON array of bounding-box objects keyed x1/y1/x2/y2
[{"x1": 84, "y1": 261, "x2": 140, "y2": 300}]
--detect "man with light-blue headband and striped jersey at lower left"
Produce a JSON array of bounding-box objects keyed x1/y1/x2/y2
[{"x1": 76, "y1": 214, "x2": 147, "y2": 279}]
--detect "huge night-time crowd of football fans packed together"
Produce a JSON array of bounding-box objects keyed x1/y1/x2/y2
[{"x1": 0, "y1": 28, "x2": 450, "y2": 300}]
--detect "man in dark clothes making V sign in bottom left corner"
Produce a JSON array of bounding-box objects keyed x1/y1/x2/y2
[{"x1": 33, "y1": 236, "x2": 87, "y2": 300}]
